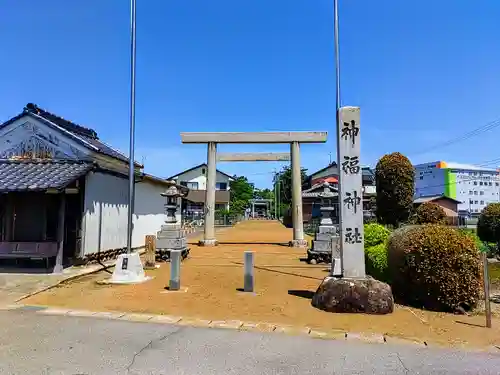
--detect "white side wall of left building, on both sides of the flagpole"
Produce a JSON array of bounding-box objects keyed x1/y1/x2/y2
[{"x1": 82, "y1": 173, "x2": 168, "y2": 255}]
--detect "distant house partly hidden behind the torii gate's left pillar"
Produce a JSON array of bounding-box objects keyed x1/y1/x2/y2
[{"x1": 168, "y1": 163, "x2": 234, "y2": 218}]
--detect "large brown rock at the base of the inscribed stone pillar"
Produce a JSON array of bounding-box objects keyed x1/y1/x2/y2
[{"x1": 311, "y1": 277, "x2": 394, "y2": 314}]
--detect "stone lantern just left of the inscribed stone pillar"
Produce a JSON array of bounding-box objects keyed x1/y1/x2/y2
[{"x1": 307, "y1": 182, "x2": 341, "y2": 268}]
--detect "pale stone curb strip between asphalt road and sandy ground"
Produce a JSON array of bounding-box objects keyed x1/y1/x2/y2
[{"x1": 0, "y1": 304, "x2": 434, "y2": 347}]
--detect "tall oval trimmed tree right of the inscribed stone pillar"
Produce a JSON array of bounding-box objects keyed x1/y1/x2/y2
[{"x1": 375, "y1": 152, "x2": 415, "y2": 227}]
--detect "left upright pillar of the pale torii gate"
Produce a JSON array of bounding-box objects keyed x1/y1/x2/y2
[{"x1": 200, "y1": 142, "x2": 217, "y2": 246}]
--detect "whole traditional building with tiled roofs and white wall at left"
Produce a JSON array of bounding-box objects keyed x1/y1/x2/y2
[{"x1": 0, "y1": 103, "x2": 170, "y2": 264}]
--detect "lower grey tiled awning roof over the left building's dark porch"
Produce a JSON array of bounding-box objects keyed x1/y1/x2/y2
[{"x1": 0, "y1": 160, "x2": 93, "y2": 192}]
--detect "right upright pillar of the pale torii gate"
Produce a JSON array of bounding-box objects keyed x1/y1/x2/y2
[{"x1": 290, "y1": 142, "x2": 307, "y2": 247}]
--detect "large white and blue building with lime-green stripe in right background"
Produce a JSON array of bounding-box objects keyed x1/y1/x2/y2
[{"x1": 415, "y1": 161, "x2": 500, "y2": 216}]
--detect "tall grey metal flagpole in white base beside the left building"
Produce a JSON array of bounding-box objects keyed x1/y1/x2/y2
[{"x1": 127, "y1": 0, "x2": 136, "y2": 254}]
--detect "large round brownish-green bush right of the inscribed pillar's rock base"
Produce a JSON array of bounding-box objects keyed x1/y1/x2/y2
[{"x1": 387, "y1": 224, "x2": 482, "y2": 312}]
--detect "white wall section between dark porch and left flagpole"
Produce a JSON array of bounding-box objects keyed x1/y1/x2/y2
[{"x1": 82, "y1": 172, "x2": 128, "y2": 255}]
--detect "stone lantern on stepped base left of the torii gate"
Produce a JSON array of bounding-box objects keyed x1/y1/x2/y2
[{"x1": 156, "y1": 181, "x2": 189, "y2": 260}]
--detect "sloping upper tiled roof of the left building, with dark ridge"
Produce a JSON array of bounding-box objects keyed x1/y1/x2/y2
[{"x1": 24, "y1": 103, "x2": 139, "y2": 165}]
